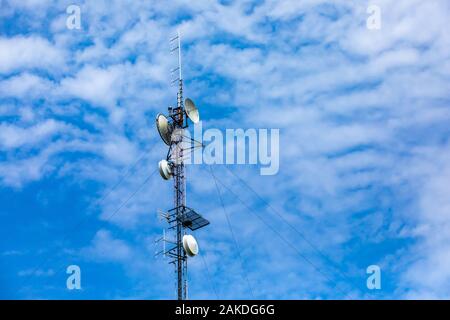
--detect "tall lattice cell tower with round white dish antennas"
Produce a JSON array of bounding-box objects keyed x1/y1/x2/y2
[{"x1": 156, "y1": 32, "x2": 209, "y2": 300}]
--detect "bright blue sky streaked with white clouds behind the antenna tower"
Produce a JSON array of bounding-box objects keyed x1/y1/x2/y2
[{"x1": 0, "y1": 0, "x2": 450, "y2": 299}]
